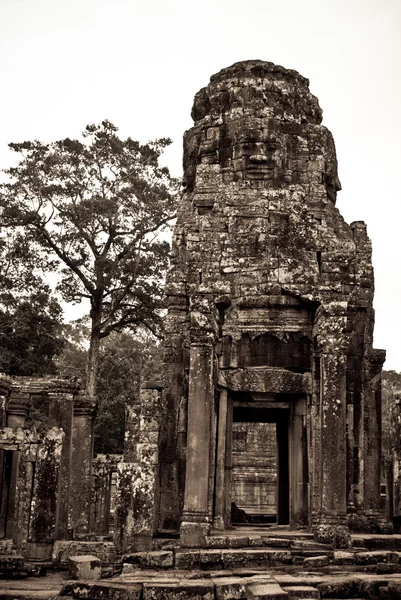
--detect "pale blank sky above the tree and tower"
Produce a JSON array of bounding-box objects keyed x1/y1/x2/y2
[{"x1": 0, "y1": 0, "x2": 401, "y2": 371}]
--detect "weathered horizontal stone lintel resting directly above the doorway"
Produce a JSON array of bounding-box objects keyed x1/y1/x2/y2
[{"x1": 218, "y1": 367, "x2": 311, "y2": 394}]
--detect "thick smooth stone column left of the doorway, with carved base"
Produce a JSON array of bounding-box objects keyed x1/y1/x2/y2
[{"x1": 181, "y1": 343, "x2": 214, "y2": 547}]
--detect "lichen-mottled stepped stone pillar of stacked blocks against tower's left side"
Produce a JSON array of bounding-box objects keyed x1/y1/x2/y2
[{"x1": 115, "y1": 385, "x2": 161, "y2": 552}]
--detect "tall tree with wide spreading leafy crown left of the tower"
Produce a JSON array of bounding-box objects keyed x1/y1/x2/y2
[{"x1": 0, "y1": 121, "x2": 177, "y2": 396}]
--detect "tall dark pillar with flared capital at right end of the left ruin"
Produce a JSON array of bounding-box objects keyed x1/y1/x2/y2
[{"x1": 69, "y1": 394, "x2": 97, "y2": 535}]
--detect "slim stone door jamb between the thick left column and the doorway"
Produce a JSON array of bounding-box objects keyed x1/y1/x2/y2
[{"x1": 213, "y1": 388, "x2": 227, "y2": 530}]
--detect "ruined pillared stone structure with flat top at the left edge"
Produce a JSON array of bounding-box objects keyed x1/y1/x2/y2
[{"x1": 0, "y1": 375, "x2": 96, "y2": 560}]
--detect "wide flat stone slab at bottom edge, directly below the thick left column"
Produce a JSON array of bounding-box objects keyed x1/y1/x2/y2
[{"x1": 143, "y1": 579, "x2": 214, "y2": 600}]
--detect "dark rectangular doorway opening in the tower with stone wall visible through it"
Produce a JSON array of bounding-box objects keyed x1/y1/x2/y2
[{"x1": 231, "y1": 406, "x2": 290, "y2": 524}]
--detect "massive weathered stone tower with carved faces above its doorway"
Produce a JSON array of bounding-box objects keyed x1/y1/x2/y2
[{"x1": 156, "y1": 60, "x2": 387, "y2": 546}]
